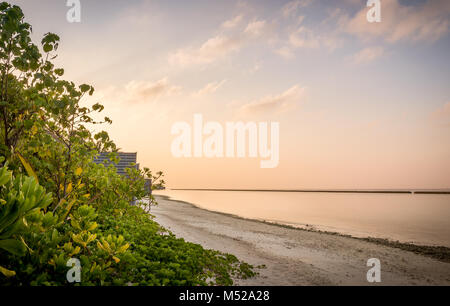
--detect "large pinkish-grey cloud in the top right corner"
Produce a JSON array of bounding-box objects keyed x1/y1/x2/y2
[{"x1": 340, "y1": 0, "x2": 450, "y2": 43}]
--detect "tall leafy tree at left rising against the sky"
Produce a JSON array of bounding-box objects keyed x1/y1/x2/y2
[{"x1": 0, "y1": 2, "x2": 116, "y2": 205}]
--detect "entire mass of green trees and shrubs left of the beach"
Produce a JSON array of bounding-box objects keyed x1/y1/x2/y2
[{"x1": 0, "y1": 2, "x2": 254, "y2": 286}]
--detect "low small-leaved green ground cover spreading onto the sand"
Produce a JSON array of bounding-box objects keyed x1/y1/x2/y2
[{"x1": 95, "y1": 207, "x2": 255, "y2": 286}]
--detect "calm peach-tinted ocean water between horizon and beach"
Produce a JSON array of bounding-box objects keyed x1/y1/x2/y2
[{"x1": 155, "y1": 190, "x2": 450, "y2": 247}]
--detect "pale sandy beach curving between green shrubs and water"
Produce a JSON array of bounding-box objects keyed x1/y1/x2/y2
[{"x1": 151, "y1": 197, "x2": 450, "y2": 286}]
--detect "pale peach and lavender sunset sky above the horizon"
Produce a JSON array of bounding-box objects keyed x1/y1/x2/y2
[{"x1": 10, "y1": 0, "x2": 450, "y2": 189}]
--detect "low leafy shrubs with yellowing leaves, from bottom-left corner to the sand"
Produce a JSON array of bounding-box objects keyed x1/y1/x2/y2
[{"x1": 0, "y1": 167, "x2": 255, "y2": 286}]
